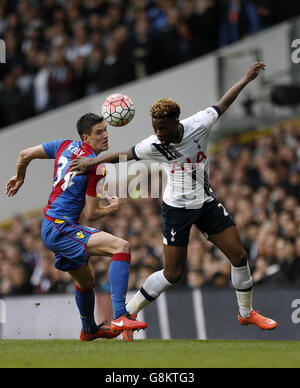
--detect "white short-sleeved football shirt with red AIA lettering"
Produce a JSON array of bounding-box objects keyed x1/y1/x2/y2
[{"x1": 132, "y1": 107, "x2": 219, "y2": 209}]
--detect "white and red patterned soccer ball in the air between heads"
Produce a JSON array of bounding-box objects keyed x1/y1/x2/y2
[{"x1": 102, "y1": 93, "x2": 135, "y2": 127}]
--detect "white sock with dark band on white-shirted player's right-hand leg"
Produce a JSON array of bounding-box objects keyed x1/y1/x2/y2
[{"x1": 231, "y1": 263, "x2": 253, "y2": 318}]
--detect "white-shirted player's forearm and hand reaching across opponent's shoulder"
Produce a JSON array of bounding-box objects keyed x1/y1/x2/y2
[{"x1": 71, "y1": 149, "x2": 133, "y2": 174}]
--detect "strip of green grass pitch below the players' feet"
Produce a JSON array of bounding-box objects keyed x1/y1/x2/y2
[{"x1": 0, "y1": 339, "x2": 300, "y2": 368}]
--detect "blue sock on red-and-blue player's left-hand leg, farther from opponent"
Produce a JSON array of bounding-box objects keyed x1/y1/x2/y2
[{"x1": 75, "y1": 285, "x2": 98, "y2": 334}]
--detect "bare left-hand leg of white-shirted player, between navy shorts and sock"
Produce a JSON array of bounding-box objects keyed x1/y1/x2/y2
[{"x1": 164, "y1": 245, "x2": 188, "y2": 283}]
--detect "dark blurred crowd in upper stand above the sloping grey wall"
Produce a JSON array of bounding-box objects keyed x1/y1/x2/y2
[{"x1": 0, "y1": 0, "x2": 300, "y2": 128}]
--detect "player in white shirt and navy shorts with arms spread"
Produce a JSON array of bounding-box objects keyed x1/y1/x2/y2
[{"x1": 71, "y1": 62, "x2": 277, "y2": 340}]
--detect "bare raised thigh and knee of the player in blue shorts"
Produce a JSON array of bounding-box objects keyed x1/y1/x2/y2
[{"x1": 86, "y1": 232, "x2": 130, "y2": 256}]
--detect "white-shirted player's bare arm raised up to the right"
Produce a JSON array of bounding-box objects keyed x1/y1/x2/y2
[{"x1": 216, "y1": 62, "x2": 266, "y2": 114}]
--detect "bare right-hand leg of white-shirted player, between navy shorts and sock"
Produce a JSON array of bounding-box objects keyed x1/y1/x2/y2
[{"x1": 209, "y1": 226, "x2": 247, "y2": 267}]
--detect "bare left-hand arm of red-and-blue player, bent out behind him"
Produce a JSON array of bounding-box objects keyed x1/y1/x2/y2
[{"x1": 5, "y1": 145, "x2": 48, "y2": 197}]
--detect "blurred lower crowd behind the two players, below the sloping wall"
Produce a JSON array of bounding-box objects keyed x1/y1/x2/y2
[{"x1": 0, "y1": 116, "x2": 300, "y2": 296}]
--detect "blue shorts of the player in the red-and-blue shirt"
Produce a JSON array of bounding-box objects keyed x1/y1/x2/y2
[{"x1": 41, "y1": 218, "x2": 101, "y2": 271}]
